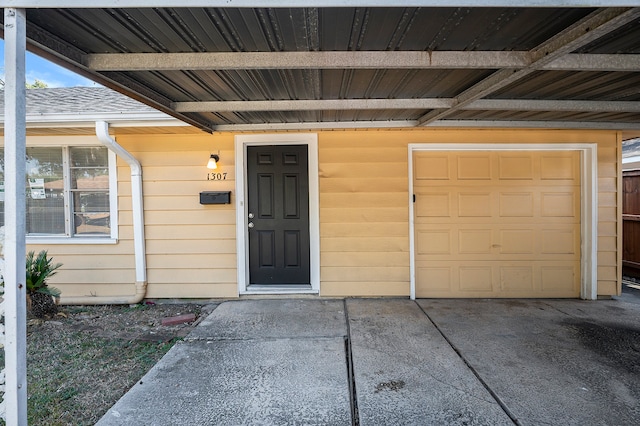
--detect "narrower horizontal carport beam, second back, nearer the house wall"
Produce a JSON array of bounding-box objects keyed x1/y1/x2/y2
[{"x1": 171, "y1": 98, "x2": 640, "y2": 112}]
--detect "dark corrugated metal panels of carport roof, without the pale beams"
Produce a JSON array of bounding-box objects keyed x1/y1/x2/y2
[{"x1": 0, "y1": 7, "x2": 640, "y2": 129}]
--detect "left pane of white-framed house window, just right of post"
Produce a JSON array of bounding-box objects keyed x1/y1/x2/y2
[{"x1": 26, "y1": 148, "x2": 65, "y2": 234}]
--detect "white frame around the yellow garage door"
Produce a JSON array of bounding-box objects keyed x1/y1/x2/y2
[{"x1": 408, "y1": 143, "x2": 598, "y2": 300}]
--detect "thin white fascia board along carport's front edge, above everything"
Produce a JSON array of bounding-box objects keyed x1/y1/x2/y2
[{"x1": 4, "y1": 0, "x2": 640, "y2": 9}]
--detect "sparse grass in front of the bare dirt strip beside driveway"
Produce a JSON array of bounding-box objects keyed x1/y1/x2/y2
[{"x1": 27, "y1": 332, "x2": 171, "y2": 426}]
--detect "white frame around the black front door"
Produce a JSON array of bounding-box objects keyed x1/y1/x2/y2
[{"x1": 234, "y1": 133, "x2": 320, "y2": 294}]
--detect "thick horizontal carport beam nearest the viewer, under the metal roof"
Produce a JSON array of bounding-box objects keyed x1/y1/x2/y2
[{"x1": 83, "y1": 51, "x2": 640, "y2": 72}]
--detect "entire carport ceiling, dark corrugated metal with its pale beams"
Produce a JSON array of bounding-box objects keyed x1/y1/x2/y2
[{"x1": 8, "y1": 7, "x2": 640, "y2": 130}]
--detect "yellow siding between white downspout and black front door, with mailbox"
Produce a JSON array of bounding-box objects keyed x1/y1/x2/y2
[{"x1": 118, "y1": 133, "x2": 237, "y2": 297}]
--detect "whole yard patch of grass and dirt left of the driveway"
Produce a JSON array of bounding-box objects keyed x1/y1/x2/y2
[{"x1": 0, "y1": 303, "x2": 217, "y2": 426}]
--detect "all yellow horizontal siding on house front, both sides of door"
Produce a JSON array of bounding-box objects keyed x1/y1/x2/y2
[{"x1": 29, "y1": 129, "x2": 621, "y2": 298}]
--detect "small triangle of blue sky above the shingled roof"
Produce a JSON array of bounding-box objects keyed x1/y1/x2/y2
[{"x1": 0, "y1": 39, "x2": 98, "y2": 87}]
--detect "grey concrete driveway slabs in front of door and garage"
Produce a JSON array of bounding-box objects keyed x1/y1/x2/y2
[{"x1": 98, "y1": 299, "x2": 640, "y2": 425}]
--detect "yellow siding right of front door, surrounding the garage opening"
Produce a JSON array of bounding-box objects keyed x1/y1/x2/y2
[{"x1": 318, "y1": 129, "x2": 621, "y2": 296}]
